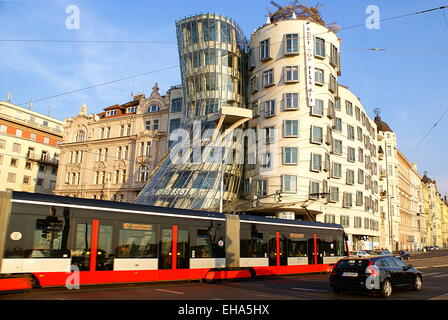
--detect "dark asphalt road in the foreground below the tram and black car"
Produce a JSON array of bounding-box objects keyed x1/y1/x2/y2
[{"x1": 0, "y1": 250, "x2": 448, "y2": 300}]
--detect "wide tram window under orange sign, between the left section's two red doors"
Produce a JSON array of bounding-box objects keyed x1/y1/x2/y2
[{"x1": 116, "y1": 230, "x2": 157, "y2": 258}]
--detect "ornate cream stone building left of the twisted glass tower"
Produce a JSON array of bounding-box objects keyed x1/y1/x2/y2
[{"x1": 55, "y1": 84, "x2": 182, "y2": 202}]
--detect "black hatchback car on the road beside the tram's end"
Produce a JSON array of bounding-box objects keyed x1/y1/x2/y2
[{"x1": 330, "y1": 256, "x2": 423, "y2": 298}]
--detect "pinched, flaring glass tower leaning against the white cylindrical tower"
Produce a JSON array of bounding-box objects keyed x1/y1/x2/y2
[{"x1": 136, "y1": 14, "x2": 249, "y2": 210}]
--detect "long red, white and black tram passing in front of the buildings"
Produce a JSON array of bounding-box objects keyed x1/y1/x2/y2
[{"x1": 0, "y1": 192, "x2": 347, "y2": 290}]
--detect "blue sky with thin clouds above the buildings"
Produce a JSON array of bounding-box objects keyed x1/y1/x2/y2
[{"x1": 0, "y1": 0, "x2": 448, "y2": 193}]
